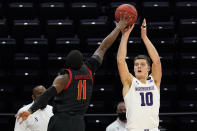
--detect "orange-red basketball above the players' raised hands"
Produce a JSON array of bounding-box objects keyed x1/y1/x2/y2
[{"x1": 115, "y1": 4, "x2": 138, "y2": 25}]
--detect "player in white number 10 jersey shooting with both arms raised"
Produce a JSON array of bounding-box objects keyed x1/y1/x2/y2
[{"x1": 117, "y1": 19, "x2": 162, "y2": 131}]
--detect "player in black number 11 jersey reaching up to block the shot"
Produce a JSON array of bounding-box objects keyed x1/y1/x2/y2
[{"x1": 16, "y1": 11, "x2": 131, "y2": 131}]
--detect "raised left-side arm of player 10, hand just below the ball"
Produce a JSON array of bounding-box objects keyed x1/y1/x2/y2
[{"x1": 117, "y1": 25, "x2": 134, "y2": 96}]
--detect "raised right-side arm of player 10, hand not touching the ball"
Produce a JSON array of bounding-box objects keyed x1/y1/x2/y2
[{"x1": 141, "y1": 19, "x2": 162, "y2": 88}]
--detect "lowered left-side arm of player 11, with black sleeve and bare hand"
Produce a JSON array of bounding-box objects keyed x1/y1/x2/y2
[{"x1": 15, "y1": 74, "x2": 69, "y2": 124}]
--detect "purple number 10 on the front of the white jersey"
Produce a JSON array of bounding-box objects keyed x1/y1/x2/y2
[{"x1": 140, "y1": 92, "x2": 153, "y2": 106}]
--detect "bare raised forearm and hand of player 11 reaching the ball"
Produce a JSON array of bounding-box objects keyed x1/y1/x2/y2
[{"x1": 93, "y1": 12, "x2": 131, "y2": 62}]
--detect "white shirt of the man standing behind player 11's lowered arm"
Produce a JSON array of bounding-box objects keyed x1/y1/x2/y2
[{"x1": 14, "y1": 103, "x2": 53, "y2": 131}]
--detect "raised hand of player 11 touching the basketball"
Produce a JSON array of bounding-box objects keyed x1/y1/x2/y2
[{"x1": 116, "y1": 12, "x2": 132, "y2": 31}]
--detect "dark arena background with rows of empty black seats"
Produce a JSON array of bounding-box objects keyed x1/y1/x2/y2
[{"x1": 0, "y1": 0, "x2": 197, "y2": 131}]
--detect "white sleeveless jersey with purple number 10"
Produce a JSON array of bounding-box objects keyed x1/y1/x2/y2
[{"x1": 124, "y1": 77, "x2": 160, "y2": 131}]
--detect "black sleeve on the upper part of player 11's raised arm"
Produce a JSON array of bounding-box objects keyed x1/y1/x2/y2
[{"x1": 86, "y1": 55, "x2": 102, "y2": 72}]
